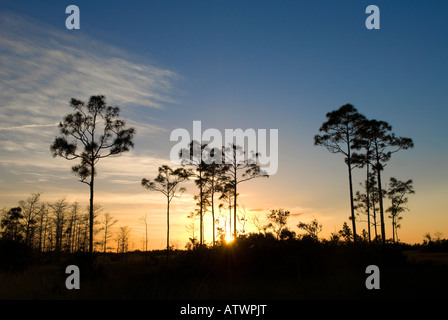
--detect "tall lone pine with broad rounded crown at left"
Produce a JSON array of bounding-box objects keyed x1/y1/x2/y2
[{"x1": 50, "y1": 95, "x2": 135, "y2": 253}]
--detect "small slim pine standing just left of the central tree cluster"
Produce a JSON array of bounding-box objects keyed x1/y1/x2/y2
[{"x1": 142, "y1": 165, "x2": 192, "y2": 252}]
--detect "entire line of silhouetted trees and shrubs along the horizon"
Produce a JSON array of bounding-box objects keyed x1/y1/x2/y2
[{"x1": 2, "y1": 95, "x2": 414, "y2": 253}]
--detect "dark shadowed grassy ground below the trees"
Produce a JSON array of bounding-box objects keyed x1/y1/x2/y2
[{"x1": 0, "y1": 239, "x2": 448, "y2": 300}]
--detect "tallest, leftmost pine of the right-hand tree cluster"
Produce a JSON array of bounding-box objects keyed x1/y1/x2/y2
[{"x1": 314, "y1": 104, "x2": 365, "y2": 242}]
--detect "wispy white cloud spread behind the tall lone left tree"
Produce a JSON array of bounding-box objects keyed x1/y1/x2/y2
[{"x1": 0, "y1": 13, "x2": 179, "y2": 202}]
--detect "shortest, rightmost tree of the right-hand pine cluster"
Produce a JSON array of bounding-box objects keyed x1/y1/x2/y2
[{"x1": 386, "y1": 177, "x2": 415, "y2": 242}]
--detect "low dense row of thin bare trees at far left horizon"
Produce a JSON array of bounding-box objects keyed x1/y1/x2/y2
[{"x1": 0, "y1": 193, "x2": 130, "y2": 253}]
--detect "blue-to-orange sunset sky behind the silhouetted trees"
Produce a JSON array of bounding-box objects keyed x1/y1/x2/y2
[{"x1": 0, "y1": 0, "x2": 448, "y2": 249}]
